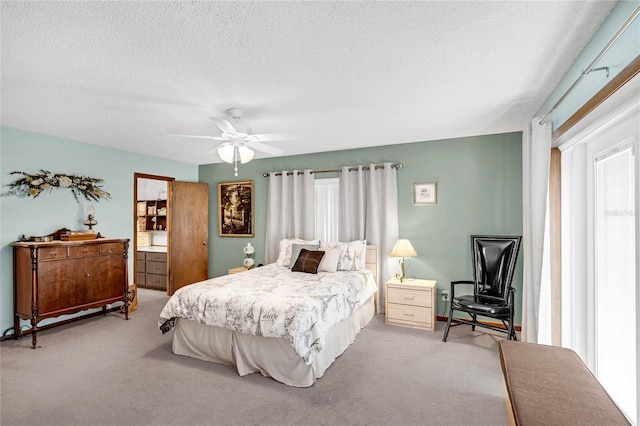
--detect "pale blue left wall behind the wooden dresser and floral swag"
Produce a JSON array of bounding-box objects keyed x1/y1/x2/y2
[{"x1": 0, "y1": 127, "x2": 198, "y2": 332}]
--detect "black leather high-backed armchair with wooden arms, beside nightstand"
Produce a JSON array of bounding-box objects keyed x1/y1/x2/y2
[{"x1": 442, "y1": 235, "x2": 522, "y2": 342}]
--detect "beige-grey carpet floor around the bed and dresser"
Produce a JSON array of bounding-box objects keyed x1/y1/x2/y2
[{"x1": 0, "y1": 289, "x2": 507, "y2": 426}]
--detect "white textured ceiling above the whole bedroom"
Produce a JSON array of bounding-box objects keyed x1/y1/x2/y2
[{"x1": 1, "y1": 1, "x2": 615, "y2": 164}]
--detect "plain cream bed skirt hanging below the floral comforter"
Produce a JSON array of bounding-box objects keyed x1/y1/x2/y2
[{"x1": 173, "y1": 297, "x2": 375, "y2": 387}]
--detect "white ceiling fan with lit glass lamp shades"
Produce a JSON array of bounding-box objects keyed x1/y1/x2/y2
[{"x1": 165, "y1": 107, "x2": 293, "y2": 176}]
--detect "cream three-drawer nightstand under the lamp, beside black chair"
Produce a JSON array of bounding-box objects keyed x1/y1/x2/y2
[{"x1": 384, "y1": 278, "x2": 436, "y2": 331}]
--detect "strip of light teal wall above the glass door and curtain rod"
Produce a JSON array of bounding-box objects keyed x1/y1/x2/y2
[{"x1": 536, "y1": 0, "x2": 640, "y2": 130}]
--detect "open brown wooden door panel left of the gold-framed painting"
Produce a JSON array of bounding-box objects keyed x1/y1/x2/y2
[{"x1": 167, "y1": 181, "x2": 209, "y2": 295}]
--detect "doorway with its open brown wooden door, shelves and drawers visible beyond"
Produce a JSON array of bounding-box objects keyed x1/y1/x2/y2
[{"x1": 132, "y1": 173, "x2": 209, "y2": 308}]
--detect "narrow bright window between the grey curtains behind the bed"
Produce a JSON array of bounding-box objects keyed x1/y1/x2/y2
[{"x1": 315, "y1": 178, "x2": 340, "y2": 241}]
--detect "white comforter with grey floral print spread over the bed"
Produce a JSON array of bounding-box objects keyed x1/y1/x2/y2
[{"x1": 158, "y1": 264, "x2": 377, "y2": 364}]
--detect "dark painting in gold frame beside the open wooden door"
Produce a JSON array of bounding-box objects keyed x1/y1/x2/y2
[{"x1": 218, "y1": 180, "x2": 254, "y2": 237}]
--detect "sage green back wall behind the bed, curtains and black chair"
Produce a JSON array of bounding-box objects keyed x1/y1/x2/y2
[{"x1": 199, "y1": 132, "x2": 522, "y2": 323}]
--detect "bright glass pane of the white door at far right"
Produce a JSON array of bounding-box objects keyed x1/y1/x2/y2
[{"x1": 594, "y1": 143, "x2": 637, "y2": 419}]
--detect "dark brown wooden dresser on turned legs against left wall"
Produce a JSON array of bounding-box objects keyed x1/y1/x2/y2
[{"x1": 11, "y1": 238, "x2": 133, "y2": 349}]
